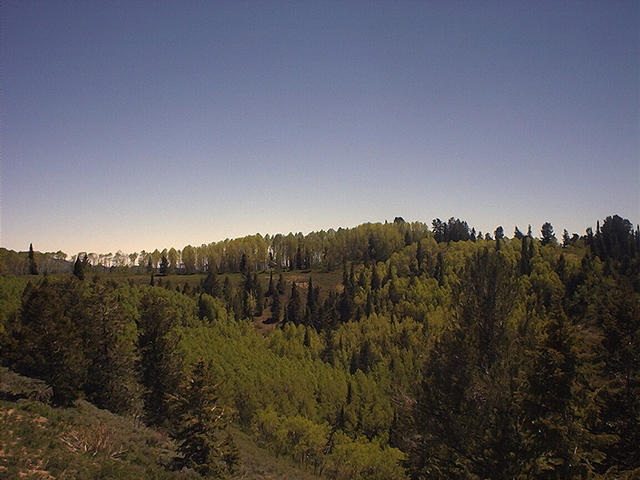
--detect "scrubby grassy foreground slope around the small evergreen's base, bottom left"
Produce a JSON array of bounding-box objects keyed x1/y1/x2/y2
[{"x1": 0, "y1": 400, "x2": 319, "y2": 480}]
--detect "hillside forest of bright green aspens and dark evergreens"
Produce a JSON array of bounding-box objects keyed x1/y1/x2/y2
[{"x1": 0, "y1": 215, "x2": 640, "y2": 479}]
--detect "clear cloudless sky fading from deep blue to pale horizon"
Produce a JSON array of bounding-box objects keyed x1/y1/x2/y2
[{"x1": 0, "y1": 0, "x2": 640, "y2": 255}]
